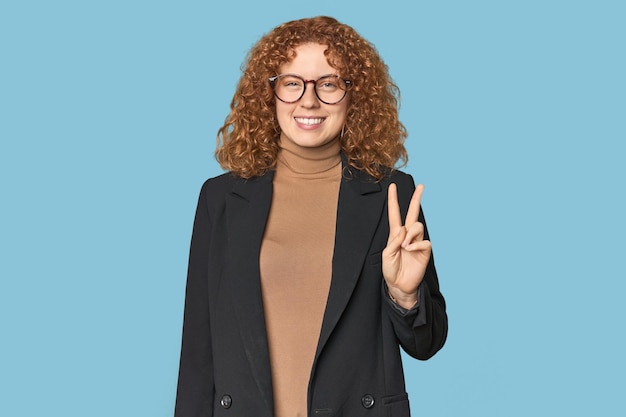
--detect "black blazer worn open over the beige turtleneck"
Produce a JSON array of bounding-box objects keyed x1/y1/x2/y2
[{"x1": 175, "y1": 162, "x2": 448, "y2": 417}]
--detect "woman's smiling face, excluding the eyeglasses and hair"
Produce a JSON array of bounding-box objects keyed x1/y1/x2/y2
[{"x1": 275, "y1": 43, "x2": 350, "y2": 148}]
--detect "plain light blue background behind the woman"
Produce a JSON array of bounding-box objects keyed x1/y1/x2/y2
[{"x1": 0, "y1": 0, "x2": 626, "y2": 417}]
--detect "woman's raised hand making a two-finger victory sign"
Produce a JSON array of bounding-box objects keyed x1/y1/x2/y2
[{"x1": 382, "y1": 184, "x2": 431, "y2": 308}]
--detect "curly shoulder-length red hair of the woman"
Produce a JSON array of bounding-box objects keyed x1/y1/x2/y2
[{"x1": 215, "y1": 16, "x2": 408, "y2": 180}]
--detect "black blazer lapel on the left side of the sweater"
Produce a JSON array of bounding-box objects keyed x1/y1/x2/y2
[{"x1": 225, "y1": 173, "x2": 274, "y2": 415}]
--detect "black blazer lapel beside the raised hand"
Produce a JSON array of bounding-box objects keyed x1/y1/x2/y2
[{"x1": 315, "y1": 168, "x2": 387, "y2": 359}]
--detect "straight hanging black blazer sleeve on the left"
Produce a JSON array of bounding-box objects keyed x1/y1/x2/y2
[{"x1": 174, "y1": 184, "x2": 214, "y2": 417}]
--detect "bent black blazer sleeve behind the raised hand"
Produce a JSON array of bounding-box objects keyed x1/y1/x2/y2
[{"x1": 383, "y1": 175, "x2": 448, "y2": 360}]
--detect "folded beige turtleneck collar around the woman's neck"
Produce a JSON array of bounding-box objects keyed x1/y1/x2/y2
[{"x1": 277, "y1": 138, "x2": 341, "y2": 176}]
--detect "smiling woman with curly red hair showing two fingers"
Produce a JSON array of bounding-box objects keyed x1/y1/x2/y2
[{"x1": 176, "y1": 17, "x2": 447, "y2": 417}]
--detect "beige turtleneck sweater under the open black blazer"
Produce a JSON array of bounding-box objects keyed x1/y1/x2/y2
[{"x1": 260, "y1": 137, "x2": 342, "y2": 417}]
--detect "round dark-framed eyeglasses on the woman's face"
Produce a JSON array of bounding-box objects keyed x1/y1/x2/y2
[{"x1": 269, "y1": 74, "x2": 352, "y2": 104}]
